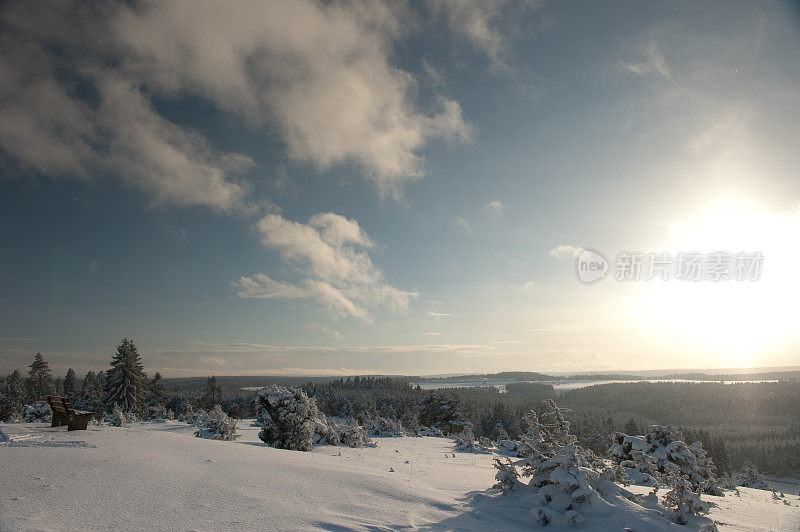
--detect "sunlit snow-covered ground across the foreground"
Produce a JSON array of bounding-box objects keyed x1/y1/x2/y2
[{"x1": 0, "y1": 421, "x2": 800, "y2": 531}]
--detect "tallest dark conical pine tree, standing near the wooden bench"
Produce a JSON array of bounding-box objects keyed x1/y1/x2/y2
[{"x1": 103, "y1": 338, "x2": 147, "y2": 414}]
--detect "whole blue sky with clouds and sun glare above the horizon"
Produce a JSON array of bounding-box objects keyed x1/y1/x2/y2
[{"x1": 0, "y1": 0, "x2": 800, "y2": 377}]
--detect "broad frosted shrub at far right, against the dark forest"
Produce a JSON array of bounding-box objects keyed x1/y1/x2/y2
[{"x1": 610, "y1": 425, "x2": 716, "y2": 492}]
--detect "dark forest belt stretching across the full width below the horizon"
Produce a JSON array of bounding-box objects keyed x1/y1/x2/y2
[{"x1": 0, "y1": 348, "x2": 800, "y2": 474}]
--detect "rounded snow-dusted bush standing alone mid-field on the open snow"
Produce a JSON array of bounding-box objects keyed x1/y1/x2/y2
[{"x1": 256, "y1": 385, "x2": 318, "y2": 451}]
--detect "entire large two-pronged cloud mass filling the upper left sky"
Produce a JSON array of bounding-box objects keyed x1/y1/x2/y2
[{"x1": 0, "y1": 0, "x2": 471, "y2": 205}]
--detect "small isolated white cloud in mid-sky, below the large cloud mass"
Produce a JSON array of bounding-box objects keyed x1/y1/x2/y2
[{"x1": 233, "y1": 213, "x2": 416, "y2": 322}]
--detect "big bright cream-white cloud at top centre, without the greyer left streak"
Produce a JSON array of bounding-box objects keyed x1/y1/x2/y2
[{"x1": 114, "y1": 0, "x2": 470, "y2": 200}]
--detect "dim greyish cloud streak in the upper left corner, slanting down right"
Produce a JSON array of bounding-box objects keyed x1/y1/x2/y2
[{"x1": 0, "y1": 3, "x2": 252, "y2": 210}]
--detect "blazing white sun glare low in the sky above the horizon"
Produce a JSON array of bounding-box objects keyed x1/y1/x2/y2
[{"x1": 639, "y1": 197, "x2": 800, "y2": 367}]
